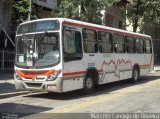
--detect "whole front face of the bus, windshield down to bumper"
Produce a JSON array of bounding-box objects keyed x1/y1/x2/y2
[{"x1": 15, "y1": 19, "x2": 62, "y2": 92}]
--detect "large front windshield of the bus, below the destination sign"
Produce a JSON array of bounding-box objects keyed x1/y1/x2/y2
[{"x1": 15, "y1": 32, "x2": 60, "y2": 68}]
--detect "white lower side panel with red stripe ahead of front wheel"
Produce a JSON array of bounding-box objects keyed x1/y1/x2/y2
[{"x1": 62, "y1": 60, "x2": 85, "y2": 92}]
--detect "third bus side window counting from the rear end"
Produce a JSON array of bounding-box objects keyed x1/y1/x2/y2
[{"x1": 125, "y1": 36, "x2": 135, "y2": 53}]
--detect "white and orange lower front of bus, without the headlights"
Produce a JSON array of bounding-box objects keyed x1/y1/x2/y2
[{"x1": 14, "y1": 63, "x2": 62, "y2": 93}]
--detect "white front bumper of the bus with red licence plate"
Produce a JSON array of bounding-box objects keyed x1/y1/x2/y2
[{"x1": 14, "y1": 78, "x2": 62, "y2": 93}]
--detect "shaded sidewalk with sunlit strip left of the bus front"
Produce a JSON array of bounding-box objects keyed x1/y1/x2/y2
[{"x1": 0, "y1": 73, "x2": 29, "y2": 99}]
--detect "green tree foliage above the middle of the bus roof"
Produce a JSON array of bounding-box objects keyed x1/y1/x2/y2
[{"x1": 54, "y1": 0, "x2": 119, "y2": 24}]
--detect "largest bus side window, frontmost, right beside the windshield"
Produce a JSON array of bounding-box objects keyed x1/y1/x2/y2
[{"x1": 63, "y1": 29, "x2": 82, "y2": 61}]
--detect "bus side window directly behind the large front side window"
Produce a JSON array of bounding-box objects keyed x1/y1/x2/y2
[{"x1": 83, "y1": 29, "x2": 98, "y2": 53}]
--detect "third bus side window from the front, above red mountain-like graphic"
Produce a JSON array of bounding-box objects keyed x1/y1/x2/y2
[{"x1": 98, "y1": 31, "x2": 112, "y2": 53}]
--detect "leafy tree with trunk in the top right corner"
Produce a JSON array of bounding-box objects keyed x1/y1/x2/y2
[{"x1": 127, "y1": 0, "x2": 160, "y2": 32}]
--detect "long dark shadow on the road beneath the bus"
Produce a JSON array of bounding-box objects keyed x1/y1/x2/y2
[{"x1": 24, "y1": 75, "x2": 160, "y2": 100}]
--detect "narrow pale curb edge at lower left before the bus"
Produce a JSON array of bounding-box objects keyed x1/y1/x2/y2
[{"x1": 0, "y1": 91, "x2": 30, "y2": 99}]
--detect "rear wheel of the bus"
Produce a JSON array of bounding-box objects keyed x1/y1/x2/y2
[{"x1": 131, "y1": 66, "x2": 140, "y2": 83}]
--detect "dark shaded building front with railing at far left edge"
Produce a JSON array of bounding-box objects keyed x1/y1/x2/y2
[{"x1": 0, "y1": 0, "x2": 15, "y2": 73}]
